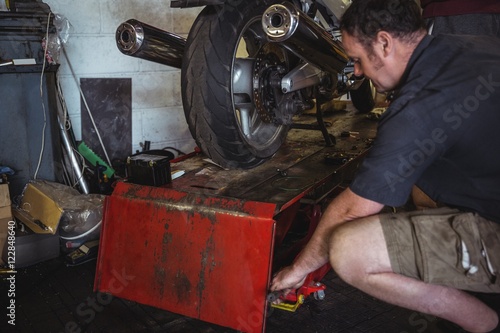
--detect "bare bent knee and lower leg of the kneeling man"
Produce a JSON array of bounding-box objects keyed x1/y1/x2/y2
[{"x1": 330, "y1": 216, "x2": 498, "y2": 332}]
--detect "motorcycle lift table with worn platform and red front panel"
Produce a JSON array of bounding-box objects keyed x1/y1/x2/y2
[{"x1": 94, "y1": 110, "x2": 376, "y2": 332}]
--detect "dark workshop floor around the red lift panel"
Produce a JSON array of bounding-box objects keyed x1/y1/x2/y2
[{"x1": 0, "y1": 252, "x2": 492, "y2": 333}]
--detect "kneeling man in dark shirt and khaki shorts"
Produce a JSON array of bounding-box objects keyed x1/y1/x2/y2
[{"x1": 271, "y1": 0, "x2": 500, "y2": 332}]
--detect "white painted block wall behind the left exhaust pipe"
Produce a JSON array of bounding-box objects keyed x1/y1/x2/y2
[{"x1": 44, "y1": 0, "x2": 200, "y2": 153}]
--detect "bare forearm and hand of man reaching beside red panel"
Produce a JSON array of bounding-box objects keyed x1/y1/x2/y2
[{"x1": 271, "y1": 189, "x2": 384, "y2": 293}]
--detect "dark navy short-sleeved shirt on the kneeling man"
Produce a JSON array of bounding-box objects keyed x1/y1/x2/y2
[{"x1": 350, "y1": 35, "x2": 500, "y2": 223}]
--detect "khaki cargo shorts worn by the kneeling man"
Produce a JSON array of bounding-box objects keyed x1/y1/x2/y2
[{"x1": 380, "y1": 207, "x2": 500, "y2": 293}]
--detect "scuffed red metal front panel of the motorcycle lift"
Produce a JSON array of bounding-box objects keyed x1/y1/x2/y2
[{"x1": 95, "y1": 183, "x2": 276, "y2": 332}]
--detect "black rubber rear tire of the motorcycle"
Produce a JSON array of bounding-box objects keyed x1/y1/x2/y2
[{"x1": 181, "y1": 1, "x2": 289, "y2": 169}]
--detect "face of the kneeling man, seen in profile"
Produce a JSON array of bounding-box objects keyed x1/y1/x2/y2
[{"x1": 342, "y1": 32, "x2": 398, "y2": 93}]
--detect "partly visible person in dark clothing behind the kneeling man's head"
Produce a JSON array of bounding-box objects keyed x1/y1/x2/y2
[{"x1": 420, "y1": 0, "x2": 500, "y2": 37}]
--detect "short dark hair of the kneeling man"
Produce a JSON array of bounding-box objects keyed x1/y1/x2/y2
[{"x1": 340, "y1": 0, "x2": 426, "y2": 49}]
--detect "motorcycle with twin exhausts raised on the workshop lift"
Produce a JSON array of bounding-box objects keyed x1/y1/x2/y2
[{"x1": 116, "y1": 0, "x2": 374, "y2": 169}]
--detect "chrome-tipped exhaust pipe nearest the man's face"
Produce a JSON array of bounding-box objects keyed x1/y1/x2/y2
[{"x1": 262, "y1": 2, "x2": 349, "y2": 74}]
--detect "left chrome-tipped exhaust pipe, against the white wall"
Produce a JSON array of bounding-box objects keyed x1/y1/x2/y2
[{"x1": 116, "y1": 19, "x2": 186, "y2": 68}]
